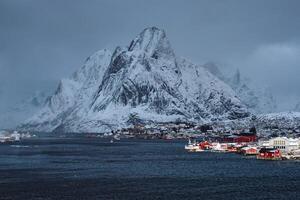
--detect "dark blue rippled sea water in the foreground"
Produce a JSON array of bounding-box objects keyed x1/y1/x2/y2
[{"x1": 0, "y1": 138, "x2": 300, "y2": 200}]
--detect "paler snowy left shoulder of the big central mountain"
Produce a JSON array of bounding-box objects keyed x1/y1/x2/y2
[{"x1": 22, "y1": 50, "x2": 111, "y2": 131}]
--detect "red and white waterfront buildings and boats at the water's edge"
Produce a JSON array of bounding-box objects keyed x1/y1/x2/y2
[{"x1": 185, "y1": 133, "x2": 300, "y2": 160}]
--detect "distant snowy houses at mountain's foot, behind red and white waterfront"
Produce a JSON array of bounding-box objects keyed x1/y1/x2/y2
[{"x1": 105, "y1": 121, "x2": 300, "y2": 143}]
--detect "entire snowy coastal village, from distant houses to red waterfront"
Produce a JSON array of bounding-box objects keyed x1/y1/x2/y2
[{"x1": 104, "y1": 122, "x2": 300, "y2": 160}]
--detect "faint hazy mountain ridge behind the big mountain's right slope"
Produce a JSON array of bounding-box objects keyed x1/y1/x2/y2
[{"x1": 203, "y1": 62, "x2": 277, "y2": 114}]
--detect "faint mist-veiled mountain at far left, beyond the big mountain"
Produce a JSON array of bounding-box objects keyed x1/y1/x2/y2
[{"x1": 0, "y1": 91, "x2": 47, "y2": 128}]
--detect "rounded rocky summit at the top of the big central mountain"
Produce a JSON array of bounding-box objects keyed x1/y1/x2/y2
[{"x1": 128, "y1": 27, "x2": 174, "y2": 58}]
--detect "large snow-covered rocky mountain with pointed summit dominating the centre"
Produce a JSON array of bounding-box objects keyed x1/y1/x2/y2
[{"x1": 21, "y1": 27, "x2": 249, "y2": 132}]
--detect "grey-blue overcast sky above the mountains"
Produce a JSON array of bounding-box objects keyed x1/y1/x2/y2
[{"x1": 0, "y1": 0, "x2": 300, "y2": 110}]
